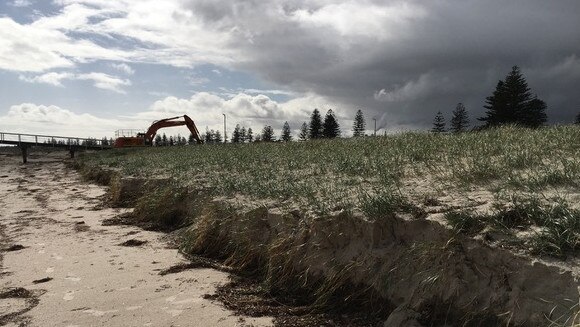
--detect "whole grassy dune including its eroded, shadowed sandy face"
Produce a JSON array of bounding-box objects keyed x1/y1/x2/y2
[{"x1": 77, "y1": 126, "x2": 580, "y2": 326}]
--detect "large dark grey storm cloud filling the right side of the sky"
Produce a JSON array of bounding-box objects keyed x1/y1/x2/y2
[{"x1": 187, "y1": 0, "x2": 580, "y2": 127}]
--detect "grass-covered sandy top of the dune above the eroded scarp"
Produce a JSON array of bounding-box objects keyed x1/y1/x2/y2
[{"x1": 80, "y1": 126, "x2": 580, "y2": 256}]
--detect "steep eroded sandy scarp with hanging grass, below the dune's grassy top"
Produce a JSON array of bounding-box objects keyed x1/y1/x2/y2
[{"x1": 81, "y1": 168, "x2": 579, "y2": 326}]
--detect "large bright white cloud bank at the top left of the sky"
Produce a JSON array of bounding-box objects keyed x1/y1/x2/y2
[{"x1": 0, "y1": 0, "x2": 236, "y2": 72}]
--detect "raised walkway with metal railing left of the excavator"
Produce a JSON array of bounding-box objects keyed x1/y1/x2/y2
[{"x1": 0, "y1": 132, "x2": 111, "y2": 149}]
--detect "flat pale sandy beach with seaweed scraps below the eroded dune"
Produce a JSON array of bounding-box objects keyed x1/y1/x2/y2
[{"x1": 0, "y1": 152, "x2": 272, "y2": 326}]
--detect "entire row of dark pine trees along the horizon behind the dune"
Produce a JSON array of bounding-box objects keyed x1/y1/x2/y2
[{"x1": 155, "y1": 66, "x2": 580, "y2": 145}]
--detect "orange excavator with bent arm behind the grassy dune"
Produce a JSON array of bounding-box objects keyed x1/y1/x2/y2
[{"x1": 114, "y1": 115, "x2": 203, "y2": 148}]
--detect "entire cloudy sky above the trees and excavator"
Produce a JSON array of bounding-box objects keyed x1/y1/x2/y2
[{"x1": 0, "y1": 0, "x2": 580, "y2": 137}]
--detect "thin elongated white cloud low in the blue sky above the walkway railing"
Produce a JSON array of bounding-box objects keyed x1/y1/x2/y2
[{"x1": 19, "y1": 72, "x2": 131, "y2": 94}]
